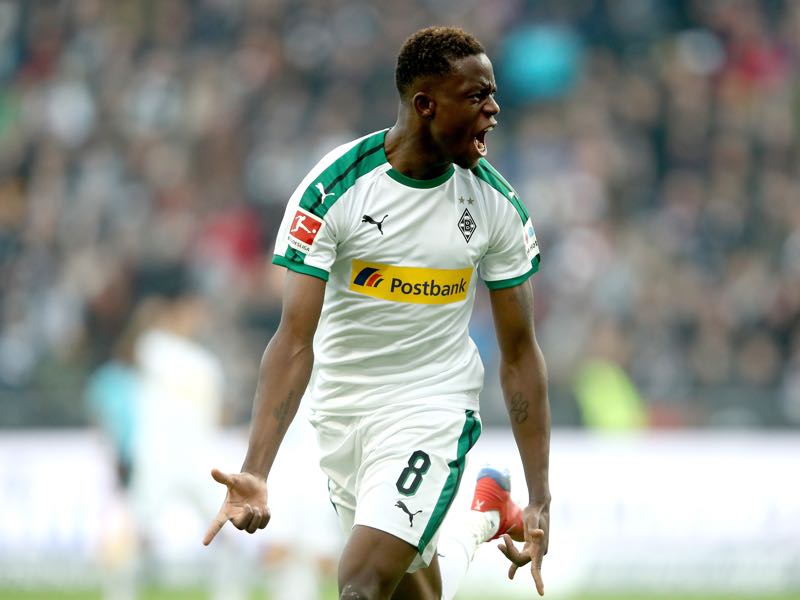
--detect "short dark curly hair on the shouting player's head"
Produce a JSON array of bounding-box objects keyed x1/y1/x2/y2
[{"x1": 394, "y1": 26, "x2": 486, "y2": 98}]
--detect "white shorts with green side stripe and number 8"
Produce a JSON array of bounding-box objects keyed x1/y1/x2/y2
[{"x1": 310, "y1": 405, "x2": 481, "y2": 573}]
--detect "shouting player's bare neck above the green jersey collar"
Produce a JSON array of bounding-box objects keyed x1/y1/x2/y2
[{"x1": 384, "y1": 116, "x2": 452, "y2": 180}]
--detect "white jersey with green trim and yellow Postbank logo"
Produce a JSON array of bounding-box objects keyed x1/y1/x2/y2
[{"x1": 273, "y1": 130, "x2": 539, "y2": 414}]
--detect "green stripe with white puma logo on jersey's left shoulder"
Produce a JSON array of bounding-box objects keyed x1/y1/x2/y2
[{"x1": 300, "y1": 131, "x2": 386, "y2": 218}]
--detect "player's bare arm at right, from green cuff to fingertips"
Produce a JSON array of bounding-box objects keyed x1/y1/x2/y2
[{"x1": 491, "y1": 282, "x2": 550, "y2": 595}]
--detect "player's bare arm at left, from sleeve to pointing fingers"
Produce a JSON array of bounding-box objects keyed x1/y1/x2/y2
[{"x1": 203, "y1": 271, "x2": 325, "y2": 545}]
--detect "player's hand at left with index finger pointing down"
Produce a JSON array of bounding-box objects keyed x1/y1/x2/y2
[{"x1": 203, "y1": 469, "x2": 270, "y2": 546}]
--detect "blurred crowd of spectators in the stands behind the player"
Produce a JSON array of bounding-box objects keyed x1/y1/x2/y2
[{"x1": 0, "y1": 0, "x2": 800, "y2": 438}]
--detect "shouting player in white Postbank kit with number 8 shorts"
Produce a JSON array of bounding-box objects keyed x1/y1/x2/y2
[{"x1": 204, "y1": 27, "x2": 550, "y2": 599}]
